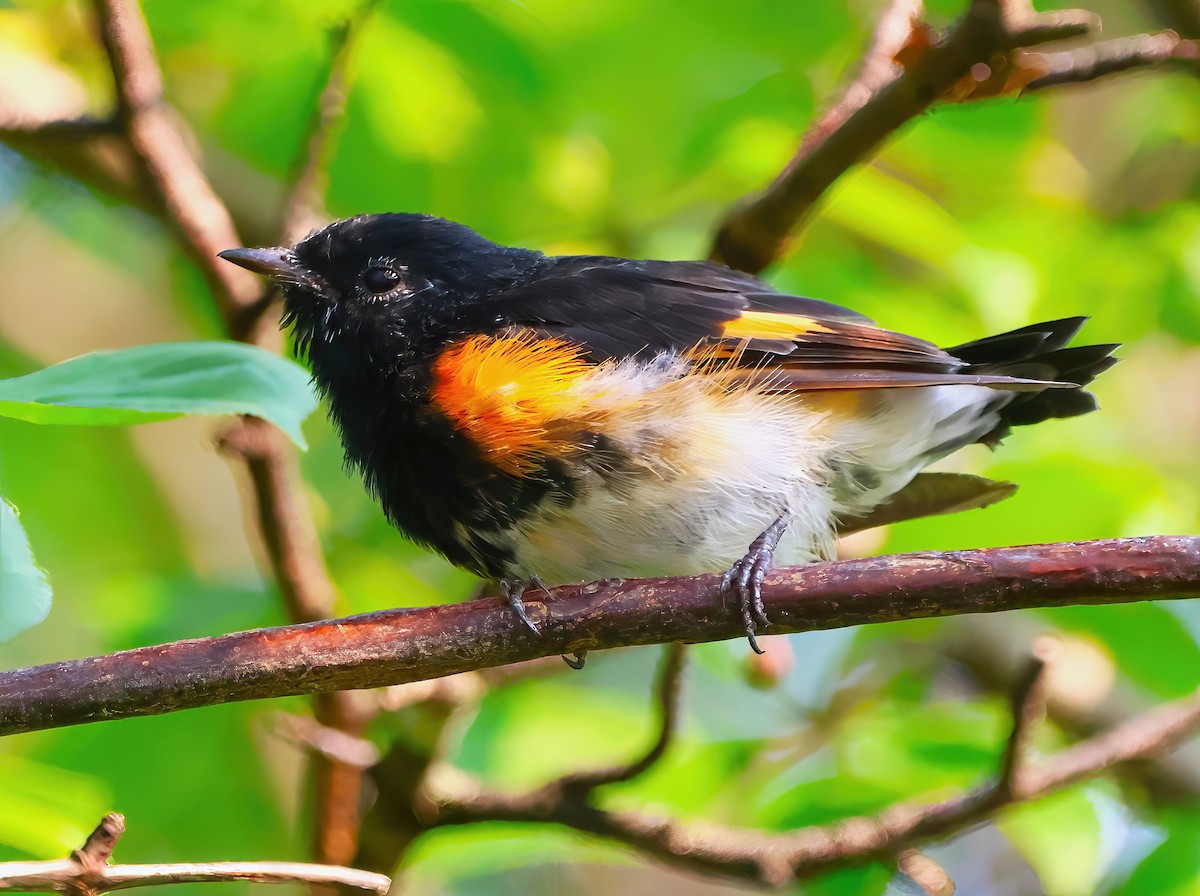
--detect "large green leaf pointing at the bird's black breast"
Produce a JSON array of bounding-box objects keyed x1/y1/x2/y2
[{"x1": 0, "y1": 342, "x2": 317, "y2": 449}]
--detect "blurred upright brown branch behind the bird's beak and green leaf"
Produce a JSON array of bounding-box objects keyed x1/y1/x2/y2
[{"x1": 87, "y1": 0, "x2": 366, "y2": 864}]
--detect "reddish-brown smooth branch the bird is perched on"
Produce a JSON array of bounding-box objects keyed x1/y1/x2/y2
[{"x1": 0, "y1": 536, "x2": 1200, "y2": 734}]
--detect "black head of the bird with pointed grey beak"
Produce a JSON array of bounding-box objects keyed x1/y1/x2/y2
[{"x1": 221, "y1": 214, "x2": 544, "y2": 367}]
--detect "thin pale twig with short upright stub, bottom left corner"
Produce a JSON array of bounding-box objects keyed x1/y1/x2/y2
[{"x1": 0, "y1": 813, "x2": 391, "y2": 896}]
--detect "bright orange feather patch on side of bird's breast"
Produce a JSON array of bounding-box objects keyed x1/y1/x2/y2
[{"x1": 431, "y1": 332, "x2": 596, "y2": 473}]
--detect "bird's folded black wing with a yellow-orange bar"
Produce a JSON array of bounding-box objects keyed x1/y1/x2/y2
[{"x1": 496, "y1": 257, "x2": 1070, "y2": 391}]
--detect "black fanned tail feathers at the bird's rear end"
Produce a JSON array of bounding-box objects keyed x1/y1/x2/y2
[{"x1": 946, "y1": 318, "x2": 1117, "y2": 445}]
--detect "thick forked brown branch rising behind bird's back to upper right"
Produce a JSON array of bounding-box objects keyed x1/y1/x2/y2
[{"x1": 710, "y1": 0, "x2": 1195, "y2": 273}]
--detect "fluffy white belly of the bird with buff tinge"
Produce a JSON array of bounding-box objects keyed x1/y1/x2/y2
[{"x1": 492, "y1": 355, "x2": 996, "y2": 585}]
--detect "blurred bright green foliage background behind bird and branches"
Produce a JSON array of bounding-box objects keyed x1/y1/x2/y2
[{"x1": 0, "y1": 0, "x2": 1200, "y2": 896}]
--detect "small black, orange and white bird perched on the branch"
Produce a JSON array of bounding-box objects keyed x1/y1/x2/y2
[{"x1": 220, "y1": 212, "x2": 1117, "y2": 665}]
